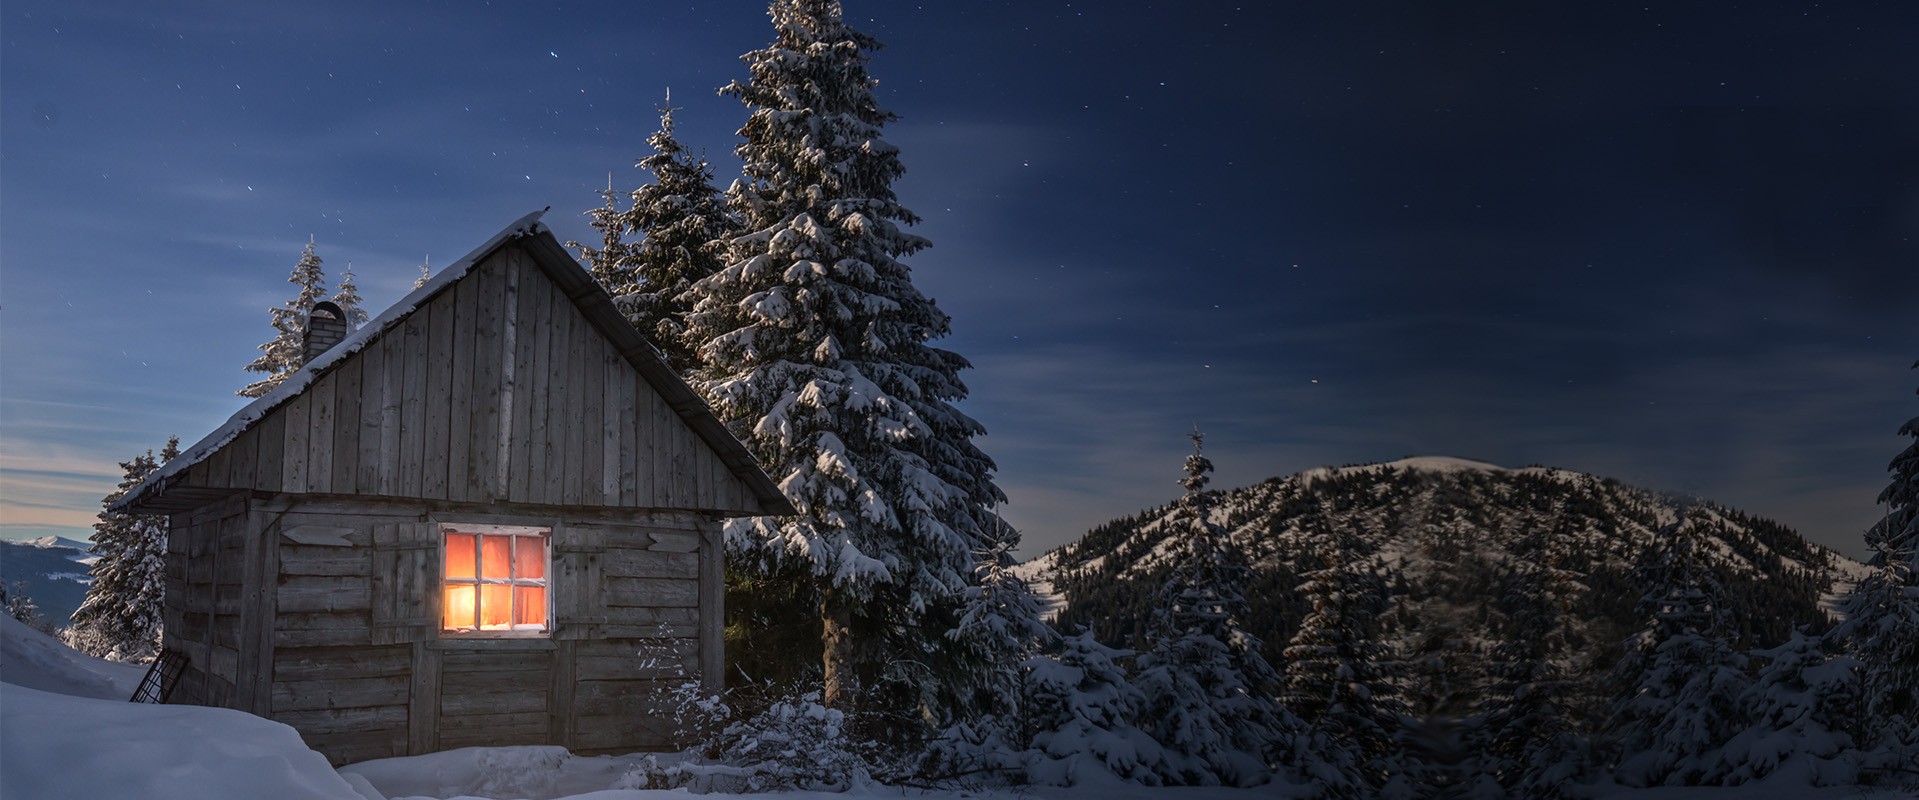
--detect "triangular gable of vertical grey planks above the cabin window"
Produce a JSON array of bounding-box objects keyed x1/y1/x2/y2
[{"x1": 172, "y1": 247, "x2": 760, "y2": 514}]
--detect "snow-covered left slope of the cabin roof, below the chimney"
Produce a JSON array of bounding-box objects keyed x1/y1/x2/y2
[{"x1": 107, "y1": 209, "x2": 551, "y2": 510}]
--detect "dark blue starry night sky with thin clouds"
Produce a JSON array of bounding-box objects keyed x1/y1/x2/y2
[{"x1": 0, "y1": 0, "x2": 1919, "y2": 554}]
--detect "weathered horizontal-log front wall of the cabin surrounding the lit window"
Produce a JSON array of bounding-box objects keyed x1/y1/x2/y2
[{"x1": 242, "y1": 497, "x2": 720, "y2": 764}]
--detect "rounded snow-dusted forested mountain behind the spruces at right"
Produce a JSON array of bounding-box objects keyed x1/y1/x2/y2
[{"x1": 1021, "y1": 457, "x2": 1863, "y2": 702}]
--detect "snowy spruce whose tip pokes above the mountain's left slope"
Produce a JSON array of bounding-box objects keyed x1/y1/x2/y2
[{"x1": 1136, "y1": 432, "x2": 1305, "y2": 787}]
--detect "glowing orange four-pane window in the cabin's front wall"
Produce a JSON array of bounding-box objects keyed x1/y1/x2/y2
[{"x1": 439, "y1": 526, "x2": 553, "y2": 635}]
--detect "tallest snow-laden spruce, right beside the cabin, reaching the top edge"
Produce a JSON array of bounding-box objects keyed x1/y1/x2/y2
[{"x1": 687, "y1": 0, "x2": 1004, "y2": 718}]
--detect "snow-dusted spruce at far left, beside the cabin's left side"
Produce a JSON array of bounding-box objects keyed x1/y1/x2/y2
[{"x1": 67, "y1": 435, "x2": 180, "y2": 662}]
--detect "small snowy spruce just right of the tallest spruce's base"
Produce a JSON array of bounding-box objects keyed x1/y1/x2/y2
[{"x1": 923, "y1": 520, "x2": 1059, "y2": 775}]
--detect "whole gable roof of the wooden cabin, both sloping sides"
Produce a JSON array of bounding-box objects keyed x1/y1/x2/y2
[{"x1": 109, "y1": 209, "x2": 794, "y2": 514}]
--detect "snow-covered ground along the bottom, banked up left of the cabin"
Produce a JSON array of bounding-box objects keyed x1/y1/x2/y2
[{"x1": 0, "y1": 614, "x2": 1911, "y2": 800}]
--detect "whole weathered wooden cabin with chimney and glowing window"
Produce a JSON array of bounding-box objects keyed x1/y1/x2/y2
[{"x1": 121, "y1": 215, "x2": 793, "y2": 764}]
